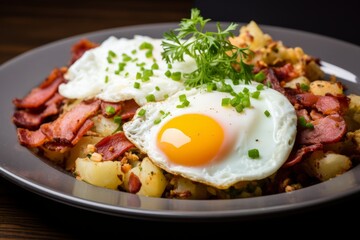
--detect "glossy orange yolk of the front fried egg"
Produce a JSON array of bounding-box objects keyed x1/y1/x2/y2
[{"x1": 157, "y1": 114, "x2": 224, "y2": 166}]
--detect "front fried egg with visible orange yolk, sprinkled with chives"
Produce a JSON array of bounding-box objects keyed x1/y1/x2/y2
[{"x1": 123, "y1": 85, "x2": 297, "y2": 189}]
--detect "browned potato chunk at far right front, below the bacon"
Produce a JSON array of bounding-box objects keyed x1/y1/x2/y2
[{"x1": 304, "y1": 151, "x2": 352, "y2": 181}]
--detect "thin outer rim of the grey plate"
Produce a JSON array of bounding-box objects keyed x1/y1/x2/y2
[{"x1": 0, "y1": 22, "x2": 360, "y2": 220}]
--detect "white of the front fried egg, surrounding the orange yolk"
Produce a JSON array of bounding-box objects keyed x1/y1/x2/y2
[{"x1": 123, "y1": 85, "x2": 297, "y2": 189}]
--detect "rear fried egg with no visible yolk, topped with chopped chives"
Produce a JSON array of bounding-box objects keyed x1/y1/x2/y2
[{"x1": 59, "y1": 35, "x2": 196, "y2": 106}]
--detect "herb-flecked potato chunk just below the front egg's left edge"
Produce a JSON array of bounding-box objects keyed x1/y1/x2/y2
[{"x1": 124, "y1": 157, "x2": 167, "y2": 197}]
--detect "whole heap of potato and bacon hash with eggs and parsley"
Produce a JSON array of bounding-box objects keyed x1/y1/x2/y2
[{"x1": 12, "y1": 9, "x2": 360, "y2": 199}]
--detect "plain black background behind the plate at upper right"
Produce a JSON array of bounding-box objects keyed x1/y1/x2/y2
[{"x1": 195, "y1": 0, "x2": 360, "y2": 46}]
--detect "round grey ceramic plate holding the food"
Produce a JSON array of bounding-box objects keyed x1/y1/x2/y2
[{"x1": 0, "y1": 23, "x2": 360, "y2": 220}]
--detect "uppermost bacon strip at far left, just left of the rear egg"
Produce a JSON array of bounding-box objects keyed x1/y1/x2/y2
[{"x1": 13, "y1": 68, "x2": 66, "y2": 109}]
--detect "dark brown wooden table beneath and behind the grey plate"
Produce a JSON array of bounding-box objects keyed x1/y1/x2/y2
[{"x1": 0, "y1": 0, "x2": 360, "y2": 239}]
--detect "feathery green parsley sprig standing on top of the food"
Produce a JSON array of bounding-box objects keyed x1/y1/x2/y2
[{"x1": 162, "y1": 8, "x2": 253, "y2": 87}]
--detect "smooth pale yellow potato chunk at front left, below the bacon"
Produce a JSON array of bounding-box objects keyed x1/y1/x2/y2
[{"x1": 74, "y1": 158, "x2": 124, "y2": 189}]
